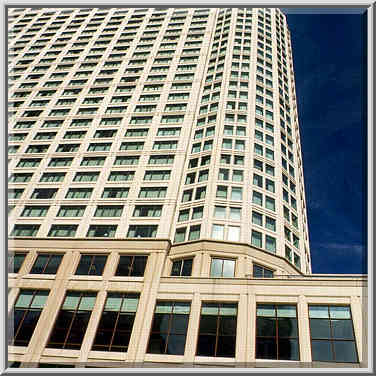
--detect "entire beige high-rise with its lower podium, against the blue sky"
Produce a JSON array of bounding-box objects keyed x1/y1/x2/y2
[{"x1": 8, "y1": 8, "x2": 367, "y2": 366}]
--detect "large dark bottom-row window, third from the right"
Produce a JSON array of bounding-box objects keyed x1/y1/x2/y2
[{"x1": 196, "y1": 303, "x2": 238, "y2": 358}]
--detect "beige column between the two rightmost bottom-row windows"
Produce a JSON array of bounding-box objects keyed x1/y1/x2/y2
[{"x1": 297, "y1": 295, "x2": 312, "y2": 362}]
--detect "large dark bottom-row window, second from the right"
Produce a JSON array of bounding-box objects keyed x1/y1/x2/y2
[{"x1": 256, "y1": 304, "x2": 299, "y2": 360}]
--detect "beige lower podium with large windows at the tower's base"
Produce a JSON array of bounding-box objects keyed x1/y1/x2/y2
[{"x1": 8, "y1": 237, "x2": 367, "y2": 368}]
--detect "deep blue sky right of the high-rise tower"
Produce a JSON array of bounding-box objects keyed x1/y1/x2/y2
[{"x1": 283, "y1": 9, "x2": 367, "y2": 273}]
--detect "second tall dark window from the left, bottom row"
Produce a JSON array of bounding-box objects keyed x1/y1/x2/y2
[{"x1": 46, "y1": 291, "x2": 97, "y2": 350}]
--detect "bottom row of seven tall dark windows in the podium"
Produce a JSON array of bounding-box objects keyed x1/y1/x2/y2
[{"x1": 9, "y1": 290, "x2": 358, "y2": 363}]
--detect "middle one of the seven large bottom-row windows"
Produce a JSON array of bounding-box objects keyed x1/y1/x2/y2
[{"x1": 147, "y1": 301, "x2": 191, "y2": 355}]
